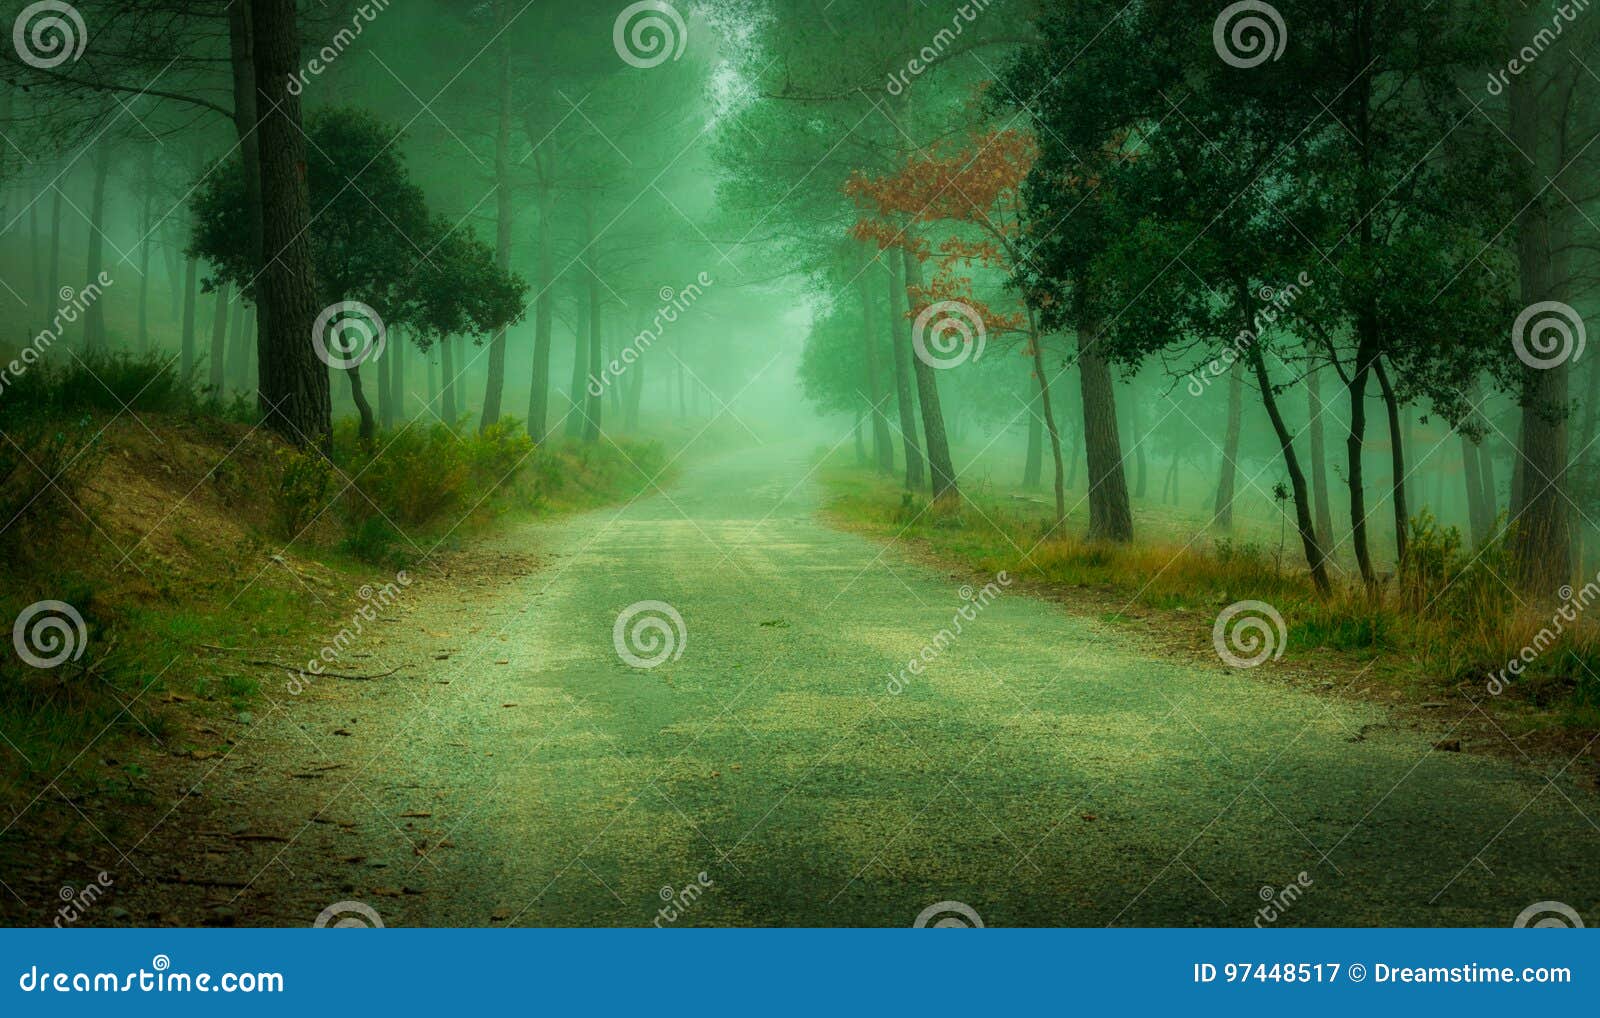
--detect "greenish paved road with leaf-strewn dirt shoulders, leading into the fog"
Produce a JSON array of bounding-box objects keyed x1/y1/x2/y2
[{"x1": 0, "y1": 450, "x2": 1600, "y2": 927}]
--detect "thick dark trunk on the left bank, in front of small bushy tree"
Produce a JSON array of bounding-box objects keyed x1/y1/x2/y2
[{"x1": 250, "y1": 0, "x2": 333, "y2": 451}]
